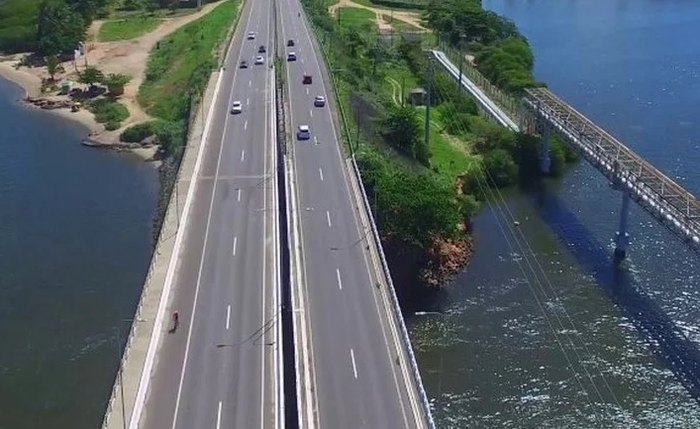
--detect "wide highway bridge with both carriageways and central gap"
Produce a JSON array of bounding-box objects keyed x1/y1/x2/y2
[{"x1": 103, "y1": 0, "x2": 434, "y2": 429}]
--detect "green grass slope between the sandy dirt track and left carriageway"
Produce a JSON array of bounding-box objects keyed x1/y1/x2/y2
[{"x1": 139, "y1": 0, "x2": 240, "y2": 121}]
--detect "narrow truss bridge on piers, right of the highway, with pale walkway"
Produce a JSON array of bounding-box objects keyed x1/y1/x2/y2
[{"x1": 431, "y1": 50, "x2": 700, "y2": 261}]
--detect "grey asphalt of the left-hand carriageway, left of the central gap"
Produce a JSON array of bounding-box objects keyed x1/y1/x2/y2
[{"x1": 141, "y1": 0, "x2": 281, "y2": 429}]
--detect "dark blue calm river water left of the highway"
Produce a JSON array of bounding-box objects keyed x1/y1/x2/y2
[{"x1": 0, "y1": 79, "x2": 158, "y2": 429}]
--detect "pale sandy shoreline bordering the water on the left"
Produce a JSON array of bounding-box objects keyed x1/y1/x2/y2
[{"x1": 0, "y1": 60, "x2": 157, "y2": 162}]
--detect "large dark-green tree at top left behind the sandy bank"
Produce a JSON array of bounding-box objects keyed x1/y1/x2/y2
[{"x1": 37, "y1": 0, "x2": 85, "y2": 56}]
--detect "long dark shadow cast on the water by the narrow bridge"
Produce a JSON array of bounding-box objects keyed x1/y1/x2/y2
[{"x1": 526, "y1": 180, "x2": 700, "y2": 404}]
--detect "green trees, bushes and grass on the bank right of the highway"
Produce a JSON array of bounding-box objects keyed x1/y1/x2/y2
[{"x1": 303, "y1": 0, "x2": 573, "y2": 285}]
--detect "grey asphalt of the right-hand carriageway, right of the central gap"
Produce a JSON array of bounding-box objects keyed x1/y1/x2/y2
[{"x1": 279, "y1": 0, "x2": 426, "y2": 429}]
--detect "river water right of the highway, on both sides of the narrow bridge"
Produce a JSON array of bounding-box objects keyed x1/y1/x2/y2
[{"x1": 408, "y1": 0, "x2": 700, "y2": 428}]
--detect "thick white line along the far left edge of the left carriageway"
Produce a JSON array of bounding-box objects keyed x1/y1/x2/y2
[{"x1": 129, "y1": 65, "x2": 224, "y2": 429}]
